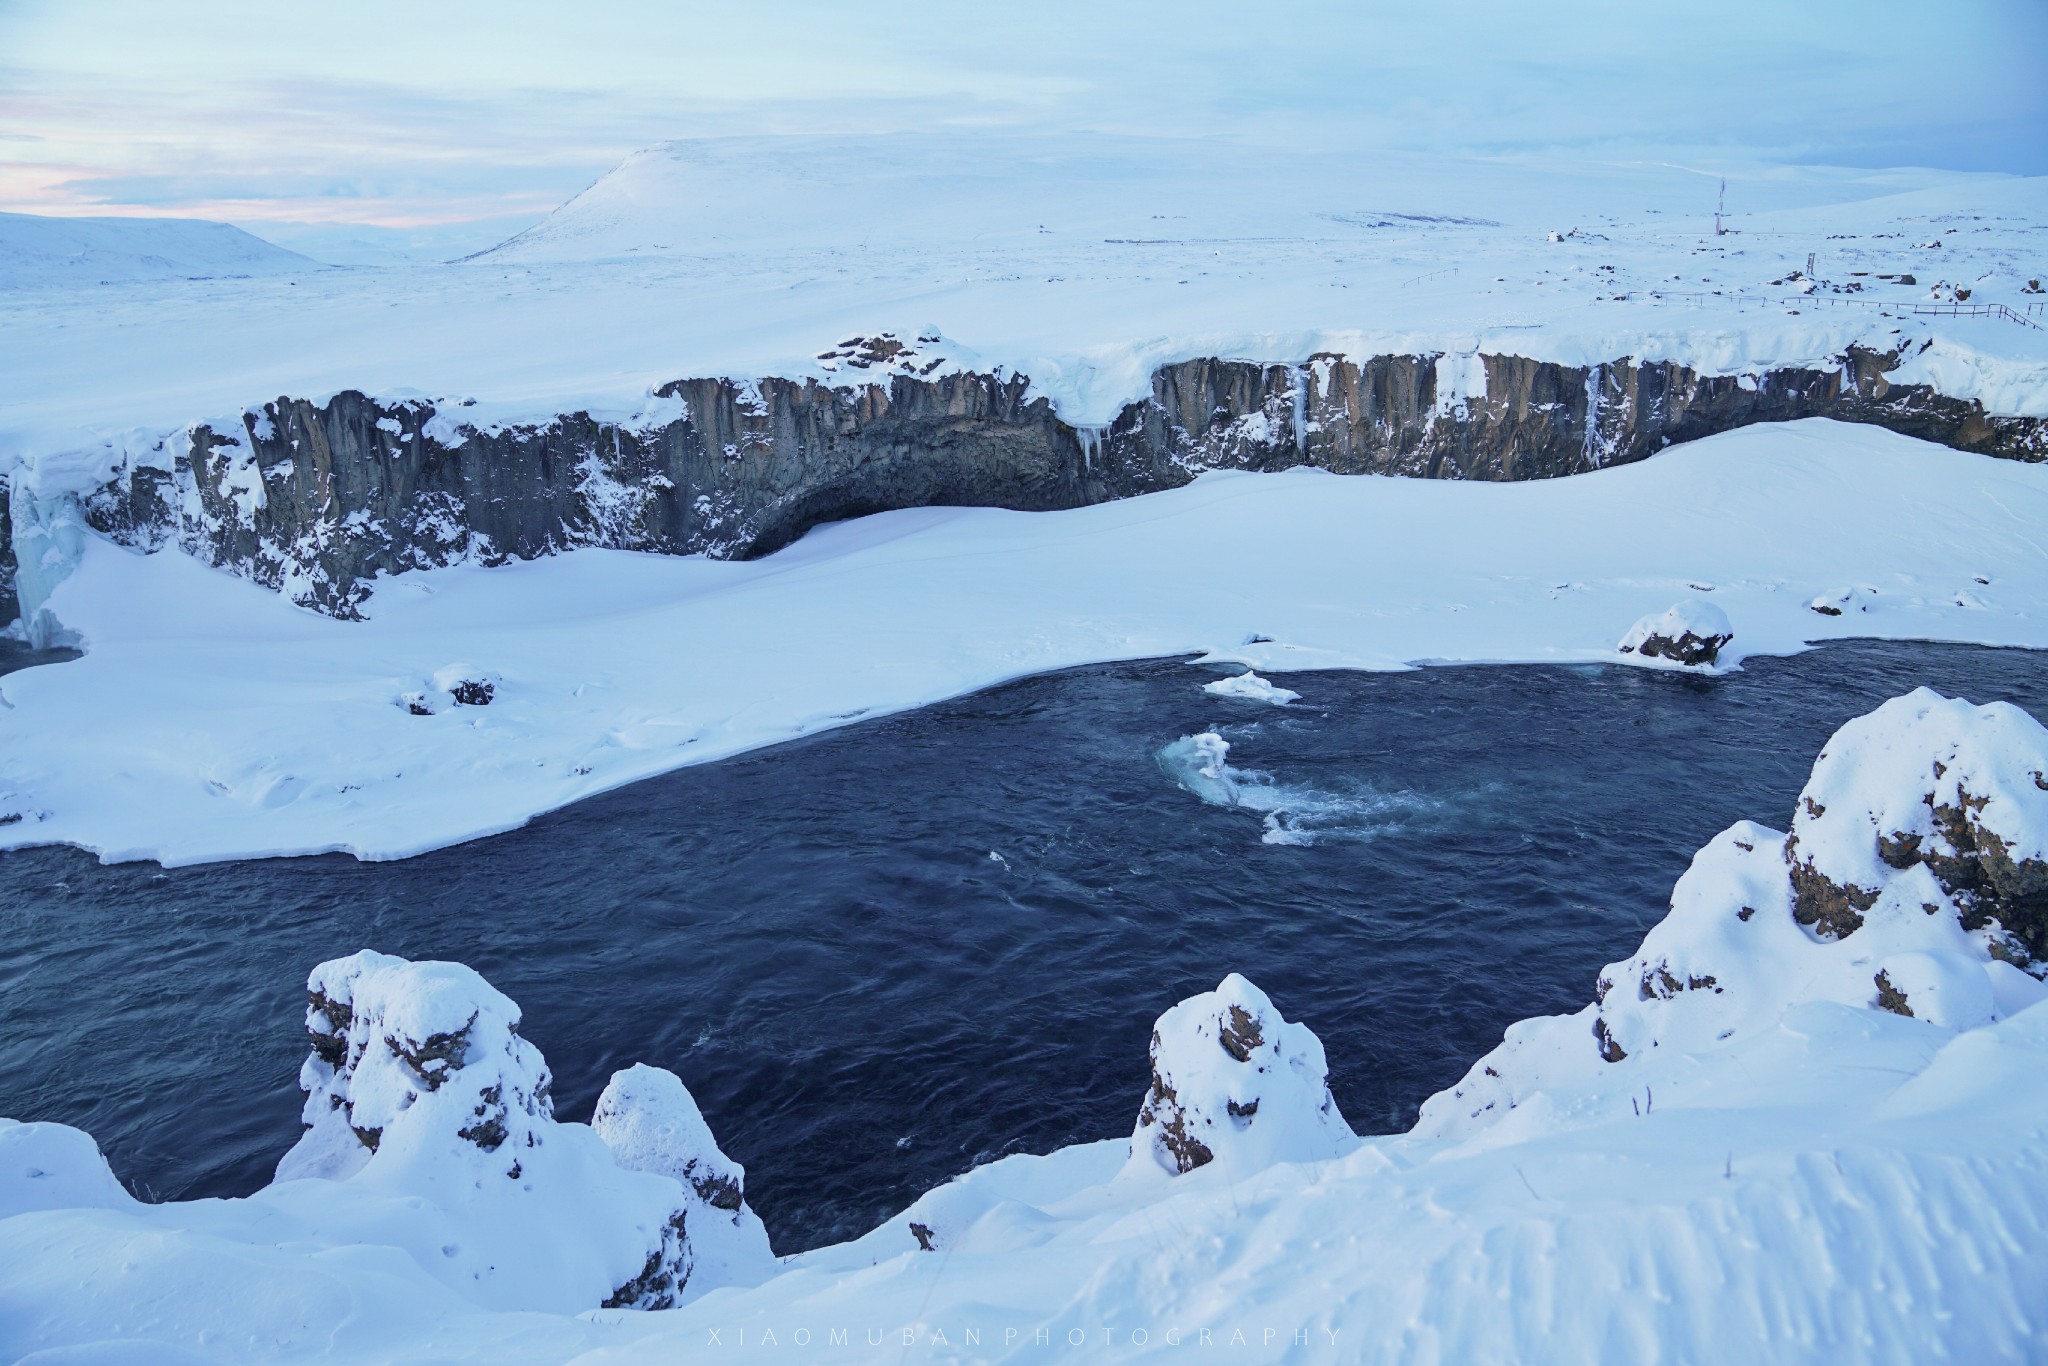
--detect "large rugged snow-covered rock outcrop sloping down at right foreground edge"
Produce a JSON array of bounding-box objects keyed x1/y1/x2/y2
[{"x1": 1417, "y1": 688, "x2": 2048, "y2": 1137}]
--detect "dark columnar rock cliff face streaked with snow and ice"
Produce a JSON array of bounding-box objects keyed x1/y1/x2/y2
[{"x1": 0, "y1": 338, "x2": 2048, "y2": 616}]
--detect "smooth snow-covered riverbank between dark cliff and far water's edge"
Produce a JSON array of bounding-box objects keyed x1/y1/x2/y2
[{"x1": 0, "y1": 422, "x2": 2048, "y2": 862}]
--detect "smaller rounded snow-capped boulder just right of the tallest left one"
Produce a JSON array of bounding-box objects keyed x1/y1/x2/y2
[{"x1": 590, "y1": 1063, "x2": 774, "y2": 1290}]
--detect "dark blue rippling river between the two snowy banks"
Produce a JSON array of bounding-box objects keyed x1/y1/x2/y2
[{"x1": 0, "y1": 643, "x2": 2048, "y2": 1251}]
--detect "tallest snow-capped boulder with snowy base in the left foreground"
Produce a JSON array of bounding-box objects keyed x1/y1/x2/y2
[{"x1": 260, "y1": 950, "x2": 737, "y2": 1313}]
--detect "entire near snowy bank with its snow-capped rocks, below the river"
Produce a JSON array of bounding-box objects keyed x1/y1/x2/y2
[{"x1": 0, "y1": 690, "x2": 2048, "y2": 1364}]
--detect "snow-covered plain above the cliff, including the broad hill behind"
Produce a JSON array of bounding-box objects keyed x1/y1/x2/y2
[{"x1": 0, "y1": 133, "x2": 2048, "y2": 494}]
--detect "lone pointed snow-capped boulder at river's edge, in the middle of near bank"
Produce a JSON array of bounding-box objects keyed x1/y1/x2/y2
[{"x1": 1124, "y1": 973, "x2": 1358, "y2": 1180}]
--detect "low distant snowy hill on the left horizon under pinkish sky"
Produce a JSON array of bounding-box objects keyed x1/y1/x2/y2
[{"x1": 0, "y1": 213, "x2": 324, "y2": 289}]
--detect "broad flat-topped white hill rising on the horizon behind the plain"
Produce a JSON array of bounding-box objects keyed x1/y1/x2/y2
[{"x1": 471, "y1": 135, "x2": 1985, "y2": 264}]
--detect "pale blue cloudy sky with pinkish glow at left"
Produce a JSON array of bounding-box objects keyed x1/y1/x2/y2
[{"x1": 0, "y1": 0, "x2": 2048, "y2": 258}]
